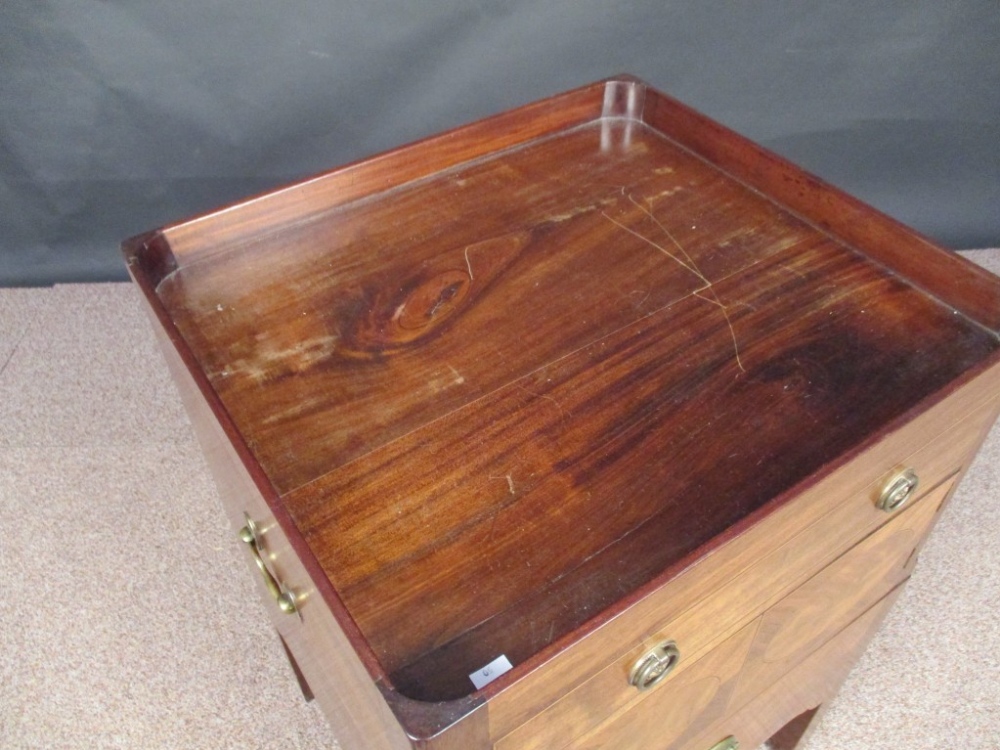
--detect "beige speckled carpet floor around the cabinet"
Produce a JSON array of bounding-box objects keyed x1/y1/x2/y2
[{"x1": 0, "y1": 250, "x2": 1000, "y2": 750}]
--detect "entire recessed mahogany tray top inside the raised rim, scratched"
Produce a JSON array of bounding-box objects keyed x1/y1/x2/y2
[{"x1": 152, "y1": 103, "x2": 997, "y2": 701}]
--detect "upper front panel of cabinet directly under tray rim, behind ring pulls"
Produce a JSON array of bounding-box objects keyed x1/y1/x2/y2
[{"x1": 489, "y1": 378, "x2": 997, "y2": 750}]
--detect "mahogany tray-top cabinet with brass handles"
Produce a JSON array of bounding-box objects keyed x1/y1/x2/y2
[{"x1": 126, "y1": 77, "x2": 1000, "y2": 748}]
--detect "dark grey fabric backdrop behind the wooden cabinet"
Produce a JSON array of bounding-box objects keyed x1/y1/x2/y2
[{"x1": 0, "y1": 0, "x2": 1000, "y2": 285}]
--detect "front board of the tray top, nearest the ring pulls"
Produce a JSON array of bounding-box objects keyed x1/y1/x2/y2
[{"x1": 287, "y1": 248, "x2": 992, "y2": 699}]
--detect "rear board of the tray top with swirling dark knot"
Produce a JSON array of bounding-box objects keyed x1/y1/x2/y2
[{"x1": 159, "y1": 122, "x2": 822, "y2": 492}]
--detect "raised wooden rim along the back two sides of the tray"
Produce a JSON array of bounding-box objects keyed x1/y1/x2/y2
[{"x1": 136, "y1": 74, "x2": 1000, "y2": 334}]
